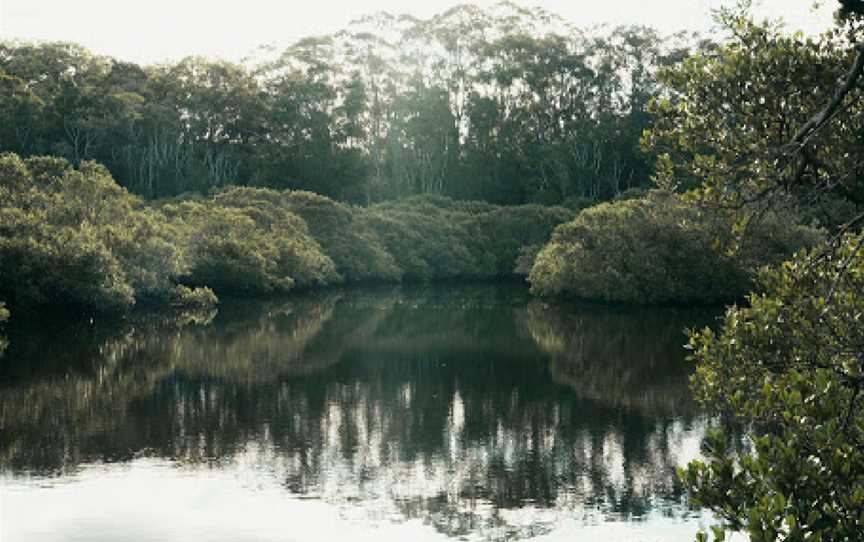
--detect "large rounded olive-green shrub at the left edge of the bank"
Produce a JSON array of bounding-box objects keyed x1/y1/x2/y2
[{"x1": 0, "y1": 154, "x2": 213, "y2": 312}]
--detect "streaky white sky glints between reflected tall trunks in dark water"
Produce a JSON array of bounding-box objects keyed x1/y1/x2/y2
[{"x1": 270, "y1": 384, "x2": 705, "y2": 515}]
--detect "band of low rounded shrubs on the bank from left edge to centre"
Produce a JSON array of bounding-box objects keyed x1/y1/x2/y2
[{"x1": 0, "y1": 154, "x2": 573, "y2": 316}]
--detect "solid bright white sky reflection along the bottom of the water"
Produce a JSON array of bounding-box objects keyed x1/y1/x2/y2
[{"x1": 0, "y1": 452, "x2": 736, "y2": 542}]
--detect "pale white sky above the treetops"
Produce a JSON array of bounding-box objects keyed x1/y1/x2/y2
[{"x1": 0, "y1": 0, "x2": 836, "y2": 63}]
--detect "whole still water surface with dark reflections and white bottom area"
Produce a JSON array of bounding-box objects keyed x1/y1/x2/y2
[{"x1": 0, "y1": 285, "x2": 716, "y2": 542}]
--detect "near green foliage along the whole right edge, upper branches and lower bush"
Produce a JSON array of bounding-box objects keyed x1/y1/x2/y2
[{"x1": 644, "y1": 0, "x2": 864, "y2": 541}]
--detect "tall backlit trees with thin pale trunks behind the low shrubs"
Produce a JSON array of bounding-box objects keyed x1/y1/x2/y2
[{"x1": 0, "y1": 2, "x2": 686, "y2": 206}]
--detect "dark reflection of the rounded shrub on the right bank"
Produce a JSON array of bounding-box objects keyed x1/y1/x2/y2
[{"x1": 522, "y1": 301, "x2": 713, "y2": 418}]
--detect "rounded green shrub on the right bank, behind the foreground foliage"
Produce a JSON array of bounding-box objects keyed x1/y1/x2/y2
[{"x1": 529, "y1": 191, "x2": 820, "y2": 304}]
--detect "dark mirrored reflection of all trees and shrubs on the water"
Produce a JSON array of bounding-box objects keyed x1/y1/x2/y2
[{"x1": 0, "y1": 286, "x2": 716, "y2": 537}]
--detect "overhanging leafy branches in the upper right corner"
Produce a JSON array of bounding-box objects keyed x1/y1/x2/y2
[{"x1": 643, "y1": 10, "x2": 864, "y2": 212}]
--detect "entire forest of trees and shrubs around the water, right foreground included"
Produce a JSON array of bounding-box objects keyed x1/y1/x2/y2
[{"x1": 0, "y1": 0, "x2": 864, "y2": 541}]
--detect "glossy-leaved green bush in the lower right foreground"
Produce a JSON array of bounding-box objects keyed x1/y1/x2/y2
[{"x1": 681, "y1": 234, "x2": 864, "y2": 541}]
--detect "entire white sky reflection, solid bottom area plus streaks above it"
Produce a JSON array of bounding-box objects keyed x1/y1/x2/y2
[{"x1": 0, "y1": 392, "x2": 705, "y2": 542}]
